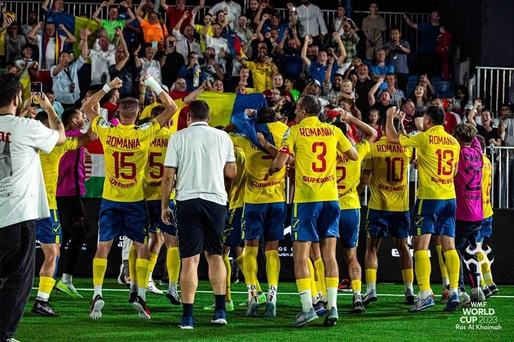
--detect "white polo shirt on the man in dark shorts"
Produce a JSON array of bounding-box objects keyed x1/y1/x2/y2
[{"x1": 164, "y1": 122, "x2": 236, "y2": 205}]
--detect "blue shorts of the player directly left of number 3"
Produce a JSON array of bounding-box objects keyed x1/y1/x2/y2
[{"x1": 242, "y1": 202, "x2": 287, "y2": 241}]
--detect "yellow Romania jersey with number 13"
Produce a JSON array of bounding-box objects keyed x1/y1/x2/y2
[{"x1": 400, "y1": 125, "x2": 460, "y2": 200}]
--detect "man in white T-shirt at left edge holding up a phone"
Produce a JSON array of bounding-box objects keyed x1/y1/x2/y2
[{"x1": 0, "y1": 75, "x2": 66, "y2": 341}]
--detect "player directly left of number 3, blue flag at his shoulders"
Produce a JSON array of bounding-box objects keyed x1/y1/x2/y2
[{"x1": 235, "y1": 107, "x2": 287, "y2": 317}]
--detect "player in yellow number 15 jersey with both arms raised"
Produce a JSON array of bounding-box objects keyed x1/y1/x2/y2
[{"x1": 84, "y1": 76, "x2": 177, "y2": 320}]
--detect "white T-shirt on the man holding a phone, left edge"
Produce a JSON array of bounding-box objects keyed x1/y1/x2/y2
[{"x1": 0, "y1": 115, "x2": 59, "y2": 229}]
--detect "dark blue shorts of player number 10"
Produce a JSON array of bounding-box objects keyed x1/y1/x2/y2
[{"x1": 366, "y1": 209, "x2": 410, "y2": 239}]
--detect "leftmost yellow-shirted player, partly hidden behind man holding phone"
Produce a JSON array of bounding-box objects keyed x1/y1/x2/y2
[{"x1": 32, "y1": 112, "x2": 95, "y2": 316}]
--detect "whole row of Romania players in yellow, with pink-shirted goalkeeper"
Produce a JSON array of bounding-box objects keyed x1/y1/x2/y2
[{"x1": 33, "y1": 77, "x2": 498, "y2": 329}]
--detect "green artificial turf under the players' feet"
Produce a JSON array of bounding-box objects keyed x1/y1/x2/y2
[{"x1": 16, "y1": 279, "x2": 514, "y2": 342}]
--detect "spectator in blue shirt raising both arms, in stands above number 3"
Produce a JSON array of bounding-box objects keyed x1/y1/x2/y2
[{"x1": 302, "y1": 32, "x2": 346, "y2": 85}]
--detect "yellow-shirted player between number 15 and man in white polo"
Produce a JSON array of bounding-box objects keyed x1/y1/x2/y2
[{"x1": 143, "y1": 105, "x2": 182, "y2": 305}]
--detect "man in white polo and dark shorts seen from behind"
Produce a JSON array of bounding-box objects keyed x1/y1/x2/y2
[{"x1": 161, "y1": 101, "x2": 237, "y2": 329}]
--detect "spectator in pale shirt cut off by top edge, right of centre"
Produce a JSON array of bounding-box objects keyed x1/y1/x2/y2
[{"x1": 287, "y1": 0, "x2": 328, "y2": 41}]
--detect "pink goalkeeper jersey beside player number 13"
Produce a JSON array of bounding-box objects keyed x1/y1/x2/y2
[{"x1": 455, "y1": 138, "x2": 484, "y2": 222}]
